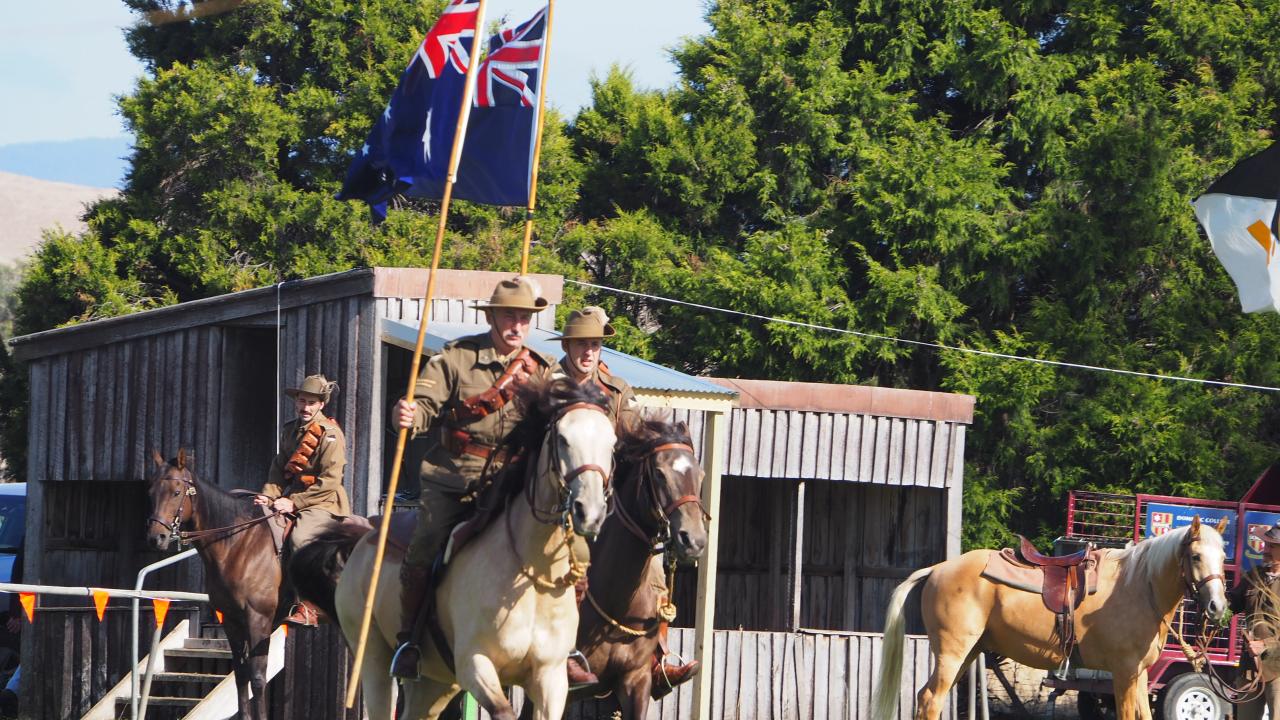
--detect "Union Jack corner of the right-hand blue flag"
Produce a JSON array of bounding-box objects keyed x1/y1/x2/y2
[{"x1": 475, "y1": 8, "x2": 547, "y2": 108}]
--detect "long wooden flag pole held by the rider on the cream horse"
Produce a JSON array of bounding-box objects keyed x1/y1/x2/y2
[{"x1": 347, "y1": 0, "x2": 486, "y2": 708}]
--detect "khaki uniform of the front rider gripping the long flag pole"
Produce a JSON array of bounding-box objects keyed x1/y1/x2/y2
[{"x1": 404, "y1": 333, "x2": 552, "y2": 568}]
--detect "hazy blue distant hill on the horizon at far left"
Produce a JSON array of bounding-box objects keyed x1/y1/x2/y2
[{"x1": 0, "y1": 137, "x2": 132, "y2": 187}]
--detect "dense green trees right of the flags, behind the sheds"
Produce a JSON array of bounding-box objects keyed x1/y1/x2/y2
[{"x1": 572, "y1": 0, "x2": 1280, "y2": 544}]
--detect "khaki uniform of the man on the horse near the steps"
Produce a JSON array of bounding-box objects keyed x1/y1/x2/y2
[{"x1": 262, "y1": 413, "x2": 351, "y2": 550}]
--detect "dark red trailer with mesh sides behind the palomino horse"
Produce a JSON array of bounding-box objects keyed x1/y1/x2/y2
[{"x1": 1044, "y1": 465, "x2": 1280, "y2": 720}]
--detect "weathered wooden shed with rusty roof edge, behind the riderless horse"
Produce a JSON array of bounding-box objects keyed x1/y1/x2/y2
[{"x1": 662, "y1": 378, "x2": 974, "y2": 719}]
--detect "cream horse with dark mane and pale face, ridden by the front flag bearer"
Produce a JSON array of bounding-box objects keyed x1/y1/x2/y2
[{"x1": 334, "y1": 380, "x2": 616, "y2": 720}]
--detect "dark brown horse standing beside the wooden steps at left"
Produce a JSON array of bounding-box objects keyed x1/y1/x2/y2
[{"x1": 147, "y1": 451, "x2": 283, "y2": 720}]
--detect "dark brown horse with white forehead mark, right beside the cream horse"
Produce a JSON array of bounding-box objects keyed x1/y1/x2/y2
[{"x1": 558, "y1": 420, "x2": 708, "y2": 720}]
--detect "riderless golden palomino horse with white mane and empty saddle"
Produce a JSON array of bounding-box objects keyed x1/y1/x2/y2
[{"x1": 872, "y1": 516, "x2": 1228, "y2": 720}]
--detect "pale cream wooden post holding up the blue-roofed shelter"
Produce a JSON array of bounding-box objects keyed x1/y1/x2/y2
[{"x1": 692, "y1": 409, "x2": 728, "y2": 717}]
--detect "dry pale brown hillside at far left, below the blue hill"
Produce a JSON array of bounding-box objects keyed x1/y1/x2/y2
[{"x1": 0, "y1": 172, "x2": 119, "y2": 263}]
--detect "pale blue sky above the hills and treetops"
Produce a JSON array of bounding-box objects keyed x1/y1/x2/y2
[{"x1": 0, "y1": 0, "x2": 707, "y2": 146}]
